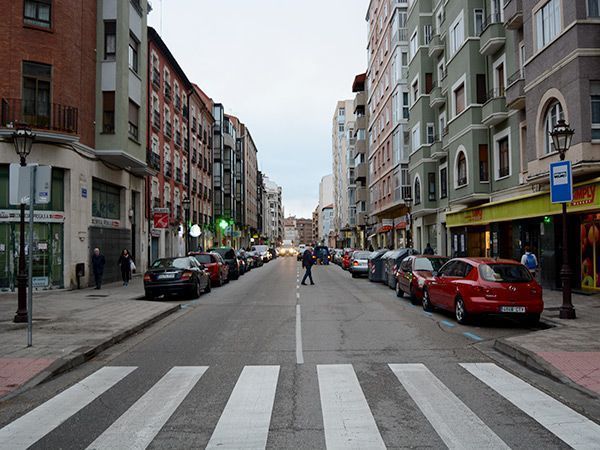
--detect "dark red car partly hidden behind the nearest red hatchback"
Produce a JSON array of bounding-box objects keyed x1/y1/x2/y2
[{"x1": 396, "y1": 255, "x2": 450, "y2": 303}]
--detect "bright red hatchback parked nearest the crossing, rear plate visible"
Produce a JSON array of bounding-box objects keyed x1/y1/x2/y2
[{"x1": 423, "y1": 258, "x2": 544, "y2": 325}]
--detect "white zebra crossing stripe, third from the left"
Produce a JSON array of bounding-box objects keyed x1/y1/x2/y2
[{"x1": 206, "y1": 366, "x2": 279, "y2": 449}]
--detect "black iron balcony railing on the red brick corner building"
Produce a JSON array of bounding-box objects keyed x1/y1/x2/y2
[{"x1": 0, "y1": 98, "x2": 79, "y2": 134}]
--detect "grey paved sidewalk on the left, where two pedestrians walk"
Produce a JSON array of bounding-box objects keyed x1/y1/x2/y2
[{"x1": 0, "y1": 277, "x2": 180, "y2": 399}]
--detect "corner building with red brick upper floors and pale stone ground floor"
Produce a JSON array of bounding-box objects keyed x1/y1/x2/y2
[{"x1": 0, "y1": 0, "x2": 148, "y2": 290}]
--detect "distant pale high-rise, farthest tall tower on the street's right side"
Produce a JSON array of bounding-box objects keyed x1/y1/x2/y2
[{"x1": 331, "y1": 100, "x2": 356, "y2": 247}]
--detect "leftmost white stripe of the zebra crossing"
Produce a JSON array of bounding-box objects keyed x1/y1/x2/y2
[{"x1": 0, "y1": 367, "x2": 136, "y2": 449}]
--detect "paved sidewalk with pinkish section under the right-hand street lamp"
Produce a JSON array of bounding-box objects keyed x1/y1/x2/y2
[{"x1": 494, "y1": 290, "x2": 600, "y2": 396}]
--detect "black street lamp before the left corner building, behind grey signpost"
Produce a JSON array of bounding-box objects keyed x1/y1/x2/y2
[{"x1": 12, "y1": 127, "x2": 35, "y2": 323}]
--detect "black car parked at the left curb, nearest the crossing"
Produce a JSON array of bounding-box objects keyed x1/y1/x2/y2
[{"x1": 144, "y1": 256, "x2": 211, "y2": 300}]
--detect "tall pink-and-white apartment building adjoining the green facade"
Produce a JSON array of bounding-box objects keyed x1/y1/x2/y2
[{"x1": 366, "y1": 0, "x2": 412, "y2": 248}]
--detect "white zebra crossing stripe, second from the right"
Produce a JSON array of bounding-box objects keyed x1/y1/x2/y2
[{"x1": 389, "y1": 364, "x2": 509, "y2": 449}]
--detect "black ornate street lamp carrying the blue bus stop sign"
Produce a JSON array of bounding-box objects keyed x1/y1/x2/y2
[{"x1": 549, "y1": 119, "x2": 575, "y2": 319}]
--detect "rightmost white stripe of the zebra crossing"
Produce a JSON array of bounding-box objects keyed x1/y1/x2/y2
[{"x1": 461, "y1": 363, "x2": 600, "y2": 448}]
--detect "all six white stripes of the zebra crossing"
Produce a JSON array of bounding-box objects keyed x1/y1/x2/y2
[{"x1": 0, "y1": 363, "x2": 600, "y2": 449}]
